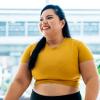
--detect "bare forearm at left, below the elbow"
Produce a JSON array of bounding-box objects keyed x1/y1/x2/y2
[{"x1": 4, "y1": 80, "x2": 29, "y2": 100}]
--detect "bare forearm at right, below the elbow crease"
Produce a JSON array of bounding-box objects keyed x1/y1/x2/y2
[{"x1": 85, "y1": 77, "x2": 99, "y2": 100}]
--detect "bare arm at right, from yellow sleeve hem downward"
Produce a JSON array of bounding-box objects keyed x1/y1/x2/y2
[{"x1": 80, "y1": 60, "x2": 99, "y2": 100}]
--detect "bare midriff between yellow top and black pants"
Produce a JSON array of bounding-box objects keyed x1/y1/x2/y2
[{"x1": 33, "y1": 83, "x2": 79, "y2": 96}]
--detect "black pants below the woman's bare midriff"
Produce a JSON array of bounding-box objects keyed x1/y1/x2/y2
[{"x1": 30, "y1": 91, "x2": 82, "y2": 100}]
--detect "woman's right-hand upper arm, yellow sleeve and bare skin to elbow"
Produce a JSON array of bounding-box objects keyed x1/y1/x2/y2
[{"x1": 78, "y1": 42, "x2": 97, "y2": 83}]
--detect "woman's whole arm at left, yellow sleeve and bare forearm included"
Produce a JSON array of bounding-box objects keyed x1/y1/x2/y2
[{"x1": 6, "y1": 45, "x2": 33, "y2": 100}]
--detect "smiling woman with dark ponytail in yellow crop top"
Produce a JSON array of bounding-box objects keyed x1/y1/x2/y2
[{"x1": 5, "y1": 5, "x2": 99, "y2": 100}]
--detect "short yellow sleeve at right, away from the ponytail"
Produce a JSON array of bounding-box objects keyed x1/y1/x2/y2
[{"x1": 78, "y1": 42, "x2": 93, "y2": 62}]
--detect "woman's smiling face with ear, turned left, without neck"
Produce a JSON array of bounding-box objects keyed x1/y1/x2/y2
[{"x1": 40, "y1": 9, "x2": 64, "y2": 37}]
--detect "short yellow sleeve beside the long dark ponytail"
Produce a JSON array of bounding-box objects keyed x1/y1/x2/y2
[{"x1": 20, "y1": 44, "x2": 35, "y2": 63}]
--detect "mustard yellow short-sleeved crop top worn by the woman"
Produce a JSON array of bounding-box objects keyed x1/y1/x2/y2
[{"x1": 21, "y1": 38, "x2": 93, "y2": 86}]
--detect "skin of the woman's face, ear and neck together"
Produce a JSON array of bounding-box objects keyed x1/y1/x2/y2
[{"x1": 40, "y1": 9, "x2": 65, "y2": 46}]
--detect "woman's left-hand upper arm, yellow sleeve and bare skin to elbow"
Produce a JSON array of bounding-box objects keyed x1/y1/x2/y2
[{"x1": 15, "y1": 44, "x2": 35, "y2": 85}]
